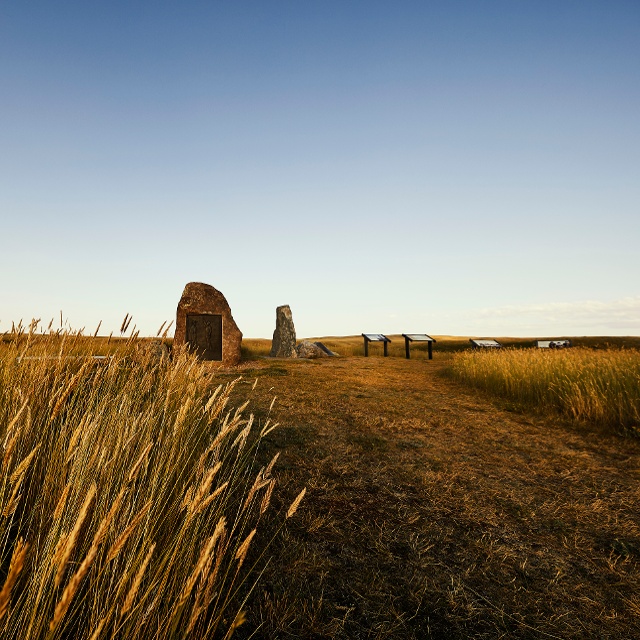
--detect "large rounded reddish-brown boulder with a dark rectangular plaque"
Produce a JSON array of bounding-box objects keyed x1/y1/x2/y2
[{"x1": 173, "y1": 282, "x2": 242, "y2": 367}]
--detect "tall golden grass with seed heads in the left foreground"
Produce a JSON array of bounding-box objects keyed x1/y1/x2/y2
[{"x1": 0, "y1": 334, "x2": 298, "y2": 640}]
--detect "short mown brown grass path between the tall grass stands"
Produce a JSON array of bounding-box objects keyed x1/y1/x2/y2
[{"x1": 215, "y1": 358, "x2": 640, "y2": 638}]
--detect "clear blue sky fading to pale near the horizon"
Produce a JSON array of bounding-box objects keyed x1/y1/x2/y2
[{"x1": 0, "y1": 0, "x2": 640, "y2": 338}]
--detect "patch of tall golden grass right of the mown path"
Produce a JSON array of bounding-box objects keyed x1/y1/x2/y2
[{"x1": 452, "y1": 348, "x2": 640, "y2": 435}]
